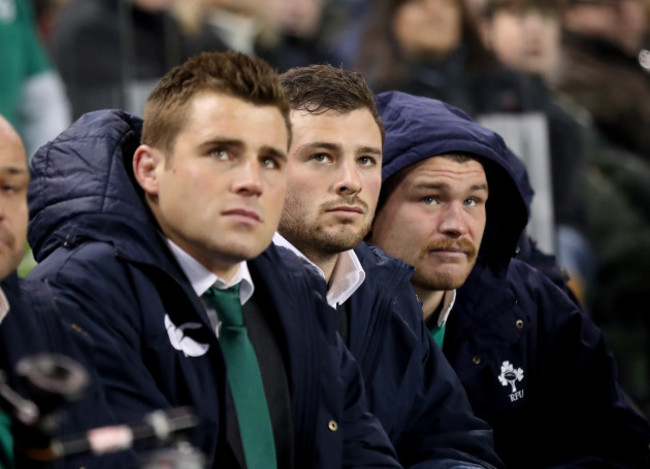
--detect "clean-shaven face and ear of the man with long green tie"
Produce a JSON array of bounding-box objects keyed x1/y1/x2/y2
[{"x1": 133, "y1": 92, "x2": 288, "y2": 279}]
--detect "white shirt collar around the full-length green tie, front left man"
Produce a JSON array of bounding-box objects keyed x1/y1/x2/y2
[{"x1": 166, "y1": 238, "x2": 255, "y2": 305}]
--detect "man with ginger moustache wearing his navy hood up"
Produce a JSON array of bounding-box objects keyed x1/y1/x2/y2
[{"x1": 371, "y1": 92, "x2": 650, "y2": 468}]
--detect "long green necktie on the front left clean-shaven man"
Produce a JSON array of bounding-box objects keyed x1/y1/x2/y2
[{"x1": 203, "y1": 284, "x2": 277, "y2": 469}]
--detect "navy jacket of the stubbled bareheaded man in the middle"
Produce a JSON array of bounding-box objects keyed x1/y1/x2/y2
[{"x1": 347, "y1": 243, "x2": 503, "y2": 469}]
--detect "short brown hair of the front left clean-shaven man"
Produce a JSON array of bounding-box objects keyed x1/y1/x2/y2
[{"x1": 142, "y1": 51, "x2": 291, "y2": 155}]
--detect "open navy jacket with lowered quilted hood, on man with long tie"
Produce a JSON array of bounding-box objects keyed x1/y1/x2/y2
[{"x1": 28, "y1": 111, "x2": 399, "y2": 468}]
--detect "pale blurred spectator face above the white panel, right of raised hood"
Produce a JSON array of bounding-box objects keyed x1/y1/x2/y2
[{"x1": 486, "y1": 7, "x2": 561, "y2": 76}]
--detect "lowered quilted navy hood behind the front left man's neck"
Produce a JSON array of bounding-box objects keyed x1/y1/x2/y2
[{"x1": 27, "y1": 110, "x2": 152, "y2": 262}]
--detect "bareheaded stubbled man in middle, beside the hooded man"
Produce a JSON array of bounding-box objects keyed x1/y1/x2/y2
[{"x1": 274, "y1": 65, "x2": 501, "y2": 468}]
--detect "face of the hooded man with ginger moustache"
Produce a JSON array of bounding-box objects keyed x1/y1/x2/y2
[{"x1": 371, "y1": 155, "x2": 488, "y2": 294}]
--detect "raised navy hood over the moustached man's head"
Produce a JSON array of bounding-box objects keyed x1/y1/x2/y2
[{"x1": 377, "y1": 91, "x2": 530, "y2": 265}]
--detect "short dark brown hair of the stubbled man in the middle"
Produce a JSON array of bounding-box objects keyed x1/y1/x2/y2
[{"x1": 280, "y1": 64, "x2": 384, "y2": 142}]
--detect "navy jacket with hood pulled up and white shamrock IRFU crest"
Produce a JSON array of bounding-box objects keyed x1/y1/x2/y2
[{"x1": 377, "y1": 92, "x2": 650, "y2": 468}]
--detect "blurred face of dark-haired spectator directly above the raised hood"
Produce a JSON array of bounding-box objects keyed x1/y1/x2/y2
[{"x1": 392, "y1": 0, "x2": 462, "y2": 59}]
